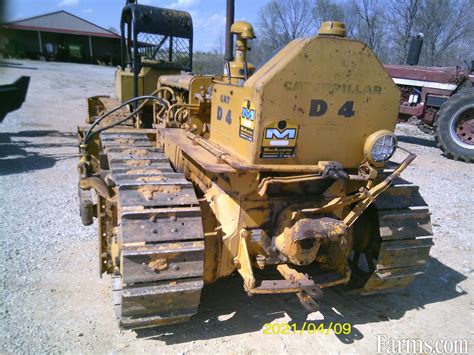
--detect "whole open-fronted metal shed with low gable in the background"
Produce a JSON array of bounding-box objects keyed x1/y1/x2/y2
[{"x1": 0, "y1": 11, "x2": 120, "y2": 64}]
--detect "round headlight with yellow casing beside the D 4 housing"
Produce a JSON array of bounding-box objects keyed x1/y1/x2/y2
[{"x1": 364, "y1": 130, "x2": 397, "y2": 165}]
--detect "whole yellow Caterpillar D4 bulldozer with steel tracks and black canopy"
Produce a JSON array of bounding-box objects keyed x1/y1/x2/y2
[{"x1": 79, "y1": 1, "x2": 433, "y2": 328}]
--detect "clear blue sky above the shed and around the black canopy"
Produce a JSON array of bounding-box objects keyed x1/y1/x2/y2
[{"x1": 0, "y1": 0, "x2": 268, "y2": 51}]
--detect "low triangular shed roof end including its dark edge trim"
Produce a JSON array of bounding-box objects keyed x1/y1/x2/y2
[{"x1": 1, "y1": 10, "x2": 120, "y2": 38}]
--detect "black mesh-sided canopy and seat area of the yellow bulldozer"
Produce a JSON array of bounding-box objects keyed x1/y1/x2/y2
[{"x1": 115, "y1": 1, "x2": 193, "y2": 102}]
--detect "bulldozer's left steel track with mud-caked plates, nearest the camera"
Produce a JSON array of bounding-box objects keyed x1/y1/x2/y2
[{"x1": 100, "y1": 129, "x2": 204, "y2": 329}]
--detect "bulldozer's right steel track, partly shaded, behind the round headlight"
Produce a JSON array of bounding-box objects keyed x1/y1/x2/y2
[{"x1": 359, "y1": 179, "x2": 433, "y2": 294}]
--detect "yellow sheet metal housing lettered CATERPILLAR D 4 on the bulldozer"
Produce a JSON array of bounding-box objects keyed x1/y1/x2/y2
[{"x1": 210, "y1": 36, "x2": 400, "y2": 168}]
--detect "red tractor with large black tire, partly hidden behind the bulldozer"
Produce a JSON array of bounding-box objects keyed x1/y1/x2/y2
[{"x1": 385, "y1": 35, "x2": 474, "y2": 162}]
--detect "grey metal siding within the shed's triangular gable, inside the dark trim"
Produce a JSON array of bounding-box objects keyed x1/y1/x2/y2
[{"x1": 7, "y1": 11, "x2": 112, "y2": 36}]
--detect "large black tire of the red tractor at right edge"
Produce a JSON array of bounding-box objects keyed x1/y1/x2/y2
[{"x1": 434, "y1": 88, "x2": 474, "y2": 163}]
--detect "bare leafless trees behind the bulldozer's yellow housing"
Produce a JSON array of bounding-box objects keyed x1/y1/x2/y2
[{"x1": 194, "y1": 0, "x2": 474, "y2": 73}]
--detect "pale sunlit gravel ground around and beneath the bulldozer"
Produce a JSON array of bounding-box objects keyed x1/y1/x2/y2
[{"x1": 0, "y1": 61, "x2": 474, "y2": 354}]
